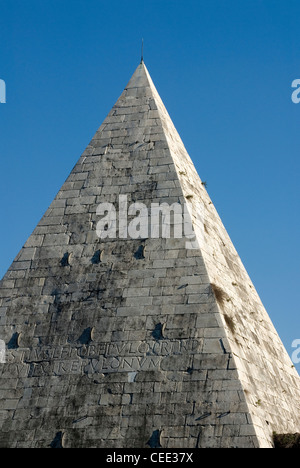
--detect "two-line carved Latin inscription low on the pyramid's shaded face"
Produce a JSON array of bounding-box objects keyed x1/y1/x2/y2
[{"x1": 18, "y1": 340, "x2": 202, "y2": 377}]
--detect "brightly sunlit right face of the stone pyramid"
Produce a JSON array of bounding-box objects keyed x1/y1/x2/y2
[{"x1": 142, "y1": 64, "x2": 300, "y2": 445}]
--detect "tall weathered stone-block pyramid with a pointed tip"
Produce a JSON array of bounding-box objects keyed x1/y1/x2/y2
[{"x1": 0, "y1": 61, "x2": 300, "y2": 449}]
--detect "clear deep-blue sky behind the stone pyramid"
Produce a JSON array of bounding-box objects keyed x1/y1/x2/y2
[{"x1": 0, "y1": 0, "x2": 300, "y2": 370}]
